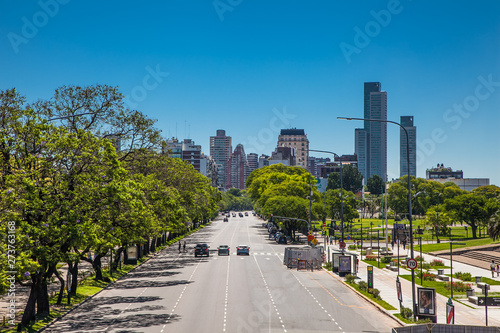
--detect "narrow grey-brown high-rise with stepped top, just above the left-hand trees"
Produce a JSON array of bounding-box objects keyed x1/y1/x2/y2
[{"x1": 210, "y1": 130, "x2": 233, "y2": 188}]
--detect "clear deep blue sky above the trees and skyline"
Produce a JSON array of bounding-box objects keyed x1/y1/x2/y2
[{"x1": 0, "y1": 0, "x2": 500, "y2": 185}]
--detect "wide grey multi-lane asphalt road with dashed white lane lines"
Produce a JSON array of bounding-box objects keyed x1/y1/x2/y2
[{"x1": 47, "y1": 214, "x2": 398, "y2": 333}]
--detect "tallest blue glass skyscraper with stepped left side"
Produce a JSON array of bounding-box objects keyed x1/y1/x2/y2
[{"x1": 354, "y1": 82, "x2": 387, "y2": 184}]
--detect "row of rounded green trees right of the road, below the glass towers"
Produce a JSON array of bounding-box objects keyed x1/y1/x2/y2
[{"x1": 247, "y1": 165, "x2": 500, "y2": 243}]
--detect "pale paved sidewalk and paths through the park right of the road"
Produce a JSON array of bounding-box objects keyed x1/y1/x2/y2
[{"x1": 322, "y1": 239, "x2": 500, "y2": 326}]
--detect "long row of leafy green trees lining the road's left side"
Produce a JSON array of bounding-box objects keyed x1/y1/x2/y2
[{"x1": 0, "y1": 85, "x2": 221, "y2": 327}]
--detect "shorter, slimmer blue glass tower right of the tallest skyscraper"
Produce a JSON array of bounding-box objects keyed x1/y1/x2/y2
[{"x1": 399, "y1": 116, "x2": 417, "y2": 177}]
